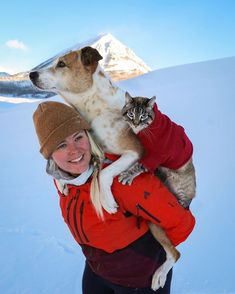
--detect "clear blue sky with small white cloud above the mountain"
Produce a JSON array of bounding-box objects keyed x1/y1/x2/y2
[{"x1": 0, "y1": 0, "x2": 235, "y2": 72}]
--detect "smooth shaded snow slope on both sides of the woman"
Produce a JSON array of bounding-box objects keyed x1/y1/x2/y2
[{"x1": 0, "y1": 57, "x2": 235, "y2": 294}]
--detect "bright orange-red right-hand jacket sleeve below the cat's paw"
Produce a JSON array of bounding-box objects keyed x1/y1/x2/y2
[{"x1": 112, "y1": 173, "x2": 195, "y2": 246}]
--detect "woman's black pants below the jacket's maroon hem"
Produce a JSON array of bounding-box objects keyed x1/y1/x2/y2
[{"x1": 82, "y1": 264, "x2": 172, "y2": 294}]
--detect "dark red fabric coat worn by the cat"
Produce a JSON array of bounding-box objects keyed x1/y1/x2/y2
[{"x1": 140, "y1": 104, "x2": 193, "y2": 172}]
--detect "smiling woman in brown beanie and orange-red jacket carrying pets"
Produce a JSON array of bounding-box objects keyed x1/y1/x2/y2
[{"x1": 33, "y1": 101, "x2": 195, "y2": 294}]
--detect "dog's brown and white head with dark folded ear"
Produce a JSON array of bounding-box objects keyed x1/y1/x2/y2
[{"x1": 29, "y1": 47, "x2": 102, "y2": 93}]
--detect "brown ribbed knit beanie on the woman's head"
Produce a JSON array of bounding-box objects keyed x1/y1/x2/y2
[{"x1": 33, "y1": 101, "x2": 90, "y2": 159}]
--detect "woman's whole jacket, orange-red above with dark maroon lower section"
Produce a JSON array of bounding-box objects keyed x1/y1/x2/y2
[{"x1": 54, "y1": 154, "x2": 195, "y2": 288}]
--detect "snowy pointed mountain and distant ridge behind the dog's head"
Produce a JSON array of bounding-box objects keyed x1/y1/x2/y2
[{"x1": 0, "y1": 34, "x2": 150, "y2": 98}]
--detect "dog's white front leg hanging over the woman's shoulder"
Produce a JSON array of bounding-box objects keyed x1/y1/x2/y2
[{"x1": 99, "y1": 151, "x2": 139, "y2": 213}]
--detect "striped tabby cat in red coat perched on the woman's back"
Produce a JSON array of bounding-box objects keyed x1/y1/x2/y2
[{"x1": 119, "y1": 93, "x2": 196, "y2": 208}]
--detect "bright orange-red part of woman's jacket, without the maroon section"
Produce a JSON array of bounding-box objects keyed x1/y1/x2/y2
[{"x1": 55, "y1": 154, "x2": 195, "y2": 253}]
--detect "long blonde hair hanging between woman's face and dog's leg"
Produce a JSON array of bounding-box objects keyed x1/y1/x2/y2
[{"x1": 85, "y1": 130, "x2": 104, "y2": 219}]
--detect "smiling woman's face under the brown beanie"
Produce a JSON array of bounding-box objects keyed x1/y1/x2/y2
[{"x1": 52, "y1": 131, "x2": 91, "y2": 175}]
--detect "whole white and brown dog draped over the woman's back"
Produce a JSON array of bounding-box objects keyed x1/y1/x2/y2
[{"x1": 29, "y1": 47, "x2": 179, "y2": 290}]
